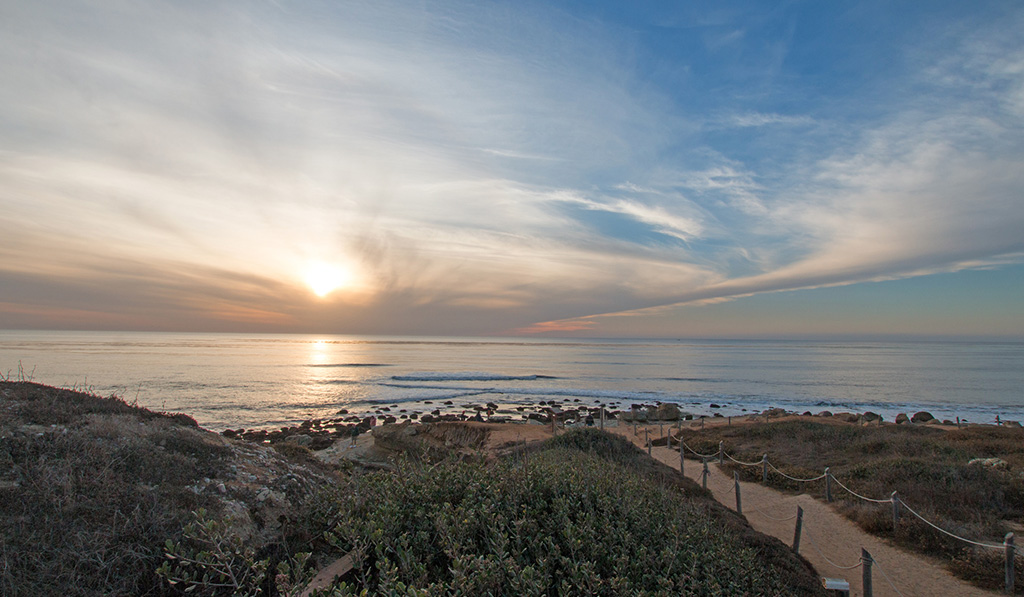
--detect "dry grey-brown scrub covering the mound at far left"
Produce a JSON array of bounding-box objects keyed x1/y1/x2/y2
[{"x1": 0, "y1": 382, "x2": 335, "y2": 596}]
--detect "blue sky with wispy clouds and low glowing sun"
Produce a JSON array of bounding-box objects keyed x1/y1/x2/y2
[{"x1": 0, "y1": 0, "x2": 1024, "y2": 339}]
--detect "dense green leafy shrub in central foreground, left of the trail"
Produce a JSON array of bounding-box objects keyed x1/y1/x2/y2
[{"x1": 311, "y1": 433, "x2": 819, "y2": 595}]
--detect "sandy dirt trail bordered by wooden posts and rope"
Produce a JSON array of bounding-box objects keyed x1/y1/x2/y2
[{"x1": 607, "y1": 426, "x2": 1000, "y2": 597}]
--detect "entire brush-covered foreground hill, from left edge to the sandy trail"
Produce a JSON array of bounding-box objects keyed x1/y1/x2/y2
[{"x1": 0, "y1": 382, "x2": 821, "y2": 595}]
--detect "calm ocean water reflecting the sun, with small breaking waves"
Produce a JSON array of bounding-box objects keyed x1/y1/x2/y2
[{"x1": 0, "y1": 331, "x2": 1024, "y2": 430}]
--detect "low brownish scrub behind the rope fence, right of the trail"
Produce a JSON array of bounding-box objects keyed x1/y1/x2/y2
[{"x1": 684, "y1": 420, "x2": 1024, "y2": 592}]
